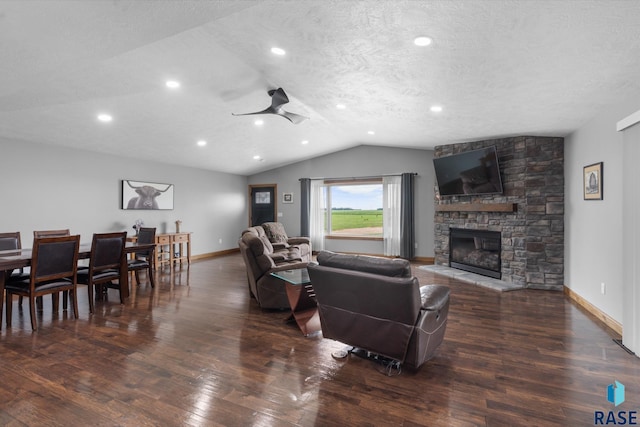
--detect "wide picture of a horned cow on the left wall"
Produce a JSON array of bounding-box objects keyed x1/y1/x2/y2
[{"x1": 122, "y1": 179, "x2": 173, "y2": 210}]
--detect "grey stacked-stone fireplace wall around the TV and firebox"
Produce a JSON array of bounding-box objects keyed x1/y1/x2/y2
[{"x1": 434, "y1": 136, "x2": 564, "y2": 290}]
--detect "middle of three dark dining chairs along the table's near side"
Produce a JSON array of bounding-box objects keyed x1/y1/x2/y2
[{"x1": 78, "y1": 231, "x2": 127, "y2": 313}]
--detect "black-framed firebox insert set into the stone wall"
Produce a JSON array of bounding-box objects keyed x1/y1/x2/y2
[{"x1": 449, "y1": 228, "x2": 502, "y2": 279}]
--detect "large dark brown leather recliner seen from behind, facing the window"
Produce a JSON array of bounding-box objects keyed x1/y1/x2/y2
[{"x1": 307, "y1": 251, "x2": 449, "y2": 369}]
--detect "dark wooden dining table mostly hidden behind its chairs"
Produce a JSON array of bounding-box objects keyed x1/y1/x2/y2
[{"x1": 0, "y1": 242, "x2": 156, "y2": 329}]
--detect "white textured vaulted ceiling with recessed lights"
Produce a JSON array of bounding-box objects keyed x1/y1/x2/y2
[{"x1": 0, "y1": 0, "x2": 640, "y2": 175}]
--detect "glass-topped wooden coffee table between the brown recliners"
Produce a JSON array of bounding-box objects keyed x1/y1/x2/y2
[{"x1": 271, "y1": 268, "x2": 322, "y2": 337}]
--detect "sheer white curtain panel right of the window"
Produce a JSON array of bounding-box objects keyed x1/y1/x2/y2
[{"x1": 382, "y1": 176, "x2": 402, "y2": 256}]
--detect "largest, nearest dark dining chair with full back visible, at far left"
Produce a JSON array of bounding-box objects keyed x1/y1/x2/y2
[{"x1": 5, "y1": 235, "x2": 80, "y2": 331}]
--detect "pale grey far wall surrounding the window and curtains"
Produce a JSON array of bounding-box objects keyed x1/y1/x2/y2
[{"x1": 249, "y1": 146, "x2": 435, "y2": 257}]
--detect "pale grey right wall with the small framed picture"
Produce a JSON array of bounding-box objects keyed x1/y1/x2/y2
[{"x1": 565, "y1": 98, "x2": 640, "y2": 323}]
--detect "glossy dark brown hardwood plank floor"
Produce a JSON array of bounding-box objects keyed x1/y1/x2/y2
[{"x1": 0, "y1": 255, "x2": 640, "y2": 426}]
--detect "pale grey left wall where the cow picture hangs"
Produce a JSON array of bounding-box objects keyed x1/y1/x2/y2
[{"x1": 0, "y1": 141, "x2": 247, "y2": 255}]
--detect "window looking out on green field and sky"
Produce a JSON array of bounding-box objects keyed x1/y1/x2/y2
[{"x1": 325, "y1": 178, "x2": 383, "y2": 239}]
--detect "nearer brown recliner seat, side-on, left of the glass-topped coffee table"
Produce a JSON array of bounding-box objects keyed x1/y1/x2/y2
[{"x1": 238, "y1": 227, "x2": 307, "y2": 309}]
